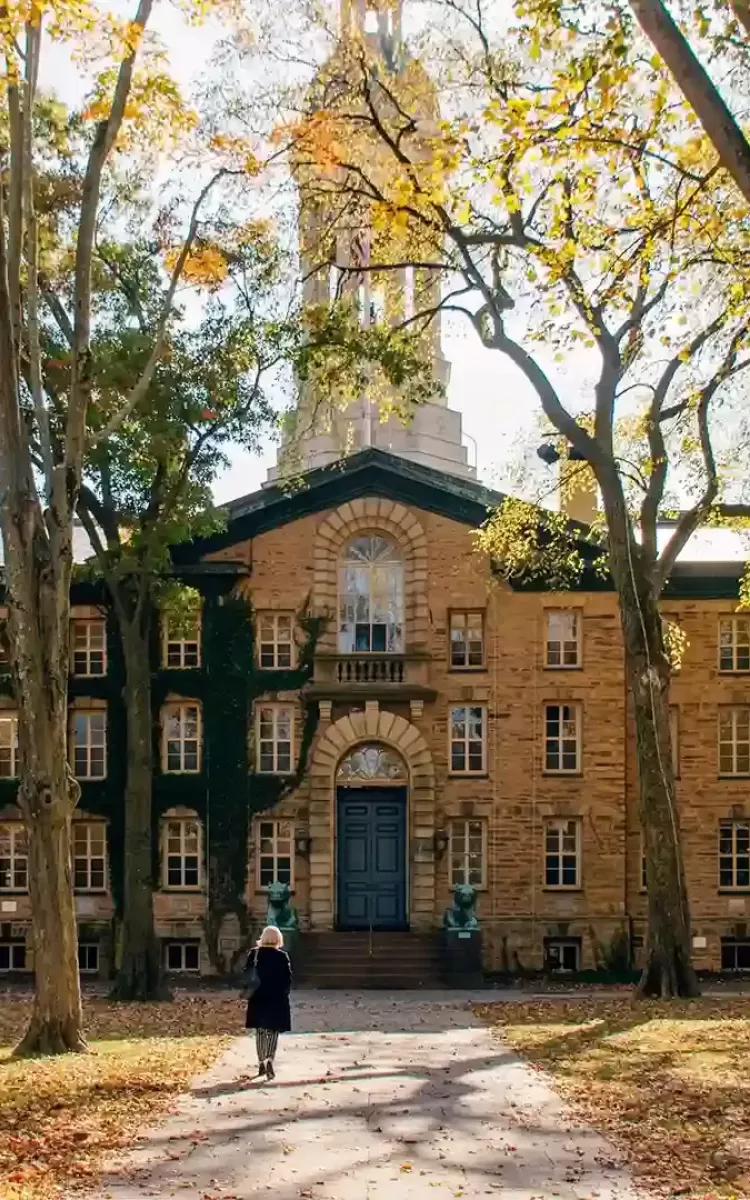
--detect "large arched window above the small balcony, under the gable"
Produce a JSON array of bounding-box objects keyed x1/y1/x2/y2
[{"x1": 338, "y1": 534, "x2": 403, "y2": 654}]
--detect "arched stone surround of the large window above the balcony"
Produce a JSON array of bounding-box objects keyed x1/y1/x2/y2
[{"x1": 313, "y1": 497, "x2": 430, "y2": 654}]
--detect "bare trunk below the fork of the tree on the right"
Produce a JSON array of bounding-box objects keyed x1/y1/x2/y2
[{"x1": 608, "y1": 520, "x2": 698, "y2": 997}]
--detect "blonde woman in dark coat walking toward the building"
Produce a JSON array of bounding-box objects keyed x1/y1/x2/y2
[{"x1": 245, "y1": 925, "x2": 292, "y2": 1079}]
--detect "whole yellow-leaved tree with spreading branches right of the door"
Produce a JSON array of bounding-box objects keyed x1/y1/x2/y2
[{"x1": 283, "y1": 0, "x2": 750, "y2": 996}]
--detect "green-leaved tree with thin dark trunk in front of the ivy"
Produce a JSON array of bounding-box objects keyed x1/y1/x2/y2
[{"x1": 72, "y1": 226, "x2": 280, "y2": 1001}]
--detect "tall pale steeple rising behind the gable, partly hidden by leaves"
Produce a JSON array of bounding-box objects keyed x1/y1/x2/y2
[{"x1": 269, "y1": 0, "x2": 475, "y2": 482}]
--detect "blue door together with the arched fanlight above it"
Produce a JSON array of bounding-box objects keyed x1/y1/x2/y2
[{"x1": 336, "y1": 742, "x2": 408, "y2": 930}]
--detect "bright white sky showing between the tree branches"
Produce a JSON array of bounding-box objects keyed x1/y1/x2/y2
[{"x1": 41, "y1": 0, "x2": 744, "y2": 558}]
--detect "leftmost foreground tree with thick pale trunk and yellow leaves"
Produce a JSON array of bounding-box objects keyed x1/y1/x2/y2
[{"x1": 0, "y1": 0, "x2": 242, "y2": 1054}]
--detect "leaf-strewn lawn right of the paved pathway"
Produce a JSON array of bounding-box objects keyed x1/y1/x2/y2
[{"x1": 479, "y1": 997, "x2": 750, "y2": 1200}]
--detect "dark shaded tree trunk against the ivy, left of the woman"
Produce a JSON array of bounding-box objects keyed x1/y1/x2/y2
[{"x1": 112, "y1": 606, "x2": 170, "y2": 1001}]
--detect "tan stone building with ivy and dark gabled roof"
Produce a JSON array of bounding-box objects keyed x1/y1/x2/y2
[{"x1": 0, "y1": 0, "x2": 750, "y2": 979}]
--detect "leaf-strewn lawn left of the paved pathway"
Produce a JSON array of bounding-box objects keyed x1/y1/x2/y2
[{"x1": 0, "y1": 994, "x2": 244, "y2": 1200}]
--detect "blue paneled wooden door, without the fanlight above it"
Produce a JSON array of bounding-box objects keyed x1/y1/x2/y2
[{"x1": 336, "y1": 787, "x2": 408, "y2": 929}]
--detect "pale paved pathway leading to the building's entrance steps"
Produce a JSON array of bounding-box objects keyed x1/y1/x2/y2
[{"x1": 97, "y1": 992, "x2": 641, "y2": 1200}]
